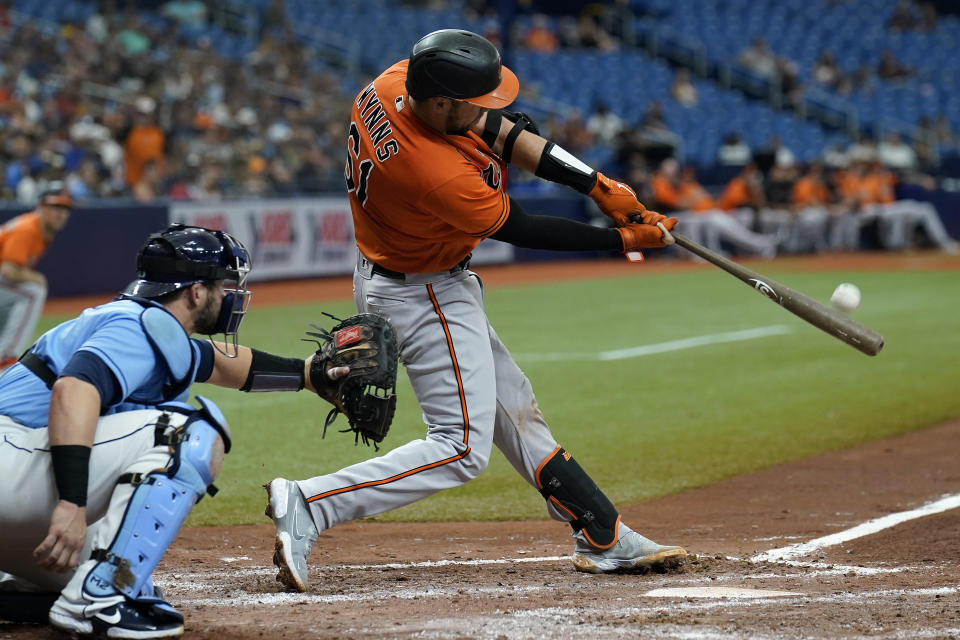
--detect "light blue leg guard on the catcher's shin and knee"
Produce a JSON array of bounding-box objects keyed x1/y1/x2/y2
[{"x1": 83, "y1": 396, "x2": 230, "y2": 599}]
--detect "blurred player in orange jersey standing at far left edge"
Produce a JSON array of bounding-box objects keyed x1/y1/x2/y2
[{"x1": 0, "y1": 182, "x2": 73, "y2": 370}]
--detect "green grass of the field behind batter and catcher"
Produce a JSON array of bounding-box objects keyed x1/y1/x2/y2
[{"x1": 33, "y1": 264, "x2": 960, "y2": 524}]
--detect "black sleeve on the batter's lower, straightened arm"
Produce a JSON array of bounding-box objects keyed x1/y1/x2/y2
[{"x1": 490, "y1": 198, "x2": 623, "y2": 251}]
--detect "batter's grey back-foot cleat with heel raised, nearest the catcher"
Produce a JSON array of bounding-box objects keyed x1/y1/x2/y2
[{"x1": 263, "y1": 478, "x2": 319, "y2": 591}]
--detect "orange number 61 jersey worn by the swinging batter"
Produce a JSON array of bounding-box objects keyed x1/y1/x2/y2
[{"x1": 345, "y1": 60, "x2": 510, "y2": 273}]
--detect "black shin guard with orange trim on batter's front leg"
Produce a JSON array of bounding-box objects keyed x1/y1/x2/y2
[{"x1": 537, "y1": 447, "x2": 620, "y2": 549}]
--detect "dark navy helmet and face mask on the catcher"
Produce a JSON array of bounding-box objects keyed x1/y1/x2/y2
[{"x1": 120, "y1": 224, "x2": 251, "y2": 358}]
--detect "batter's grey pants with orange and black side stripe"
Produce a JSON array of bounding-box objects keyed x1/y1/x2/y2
[{"x1": 297, "y1": 252, "x2": 569, "y2": 530}]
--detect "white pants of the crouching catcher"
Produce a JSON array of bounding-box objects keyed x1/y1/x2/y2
[{"x1": 0, "y1": 410, "x2": 186, "y2": 596}]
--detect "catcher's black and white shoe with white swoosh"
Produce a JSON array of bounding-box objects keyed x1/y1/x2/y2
[{"x1": 50, "y1": 600, "x2": 183, "y2": 640}]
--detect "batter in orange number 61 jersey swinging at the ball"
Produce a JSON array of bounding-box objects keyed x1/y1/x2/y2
[{"x1": 267, "y1": 29, "x2": 686, "y2": 591}]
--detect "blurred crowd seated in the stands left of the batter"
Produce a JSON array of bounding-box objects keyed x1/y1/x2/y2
[{"x1": 0, "y1": 0, "x2": 350, "y2": 204}]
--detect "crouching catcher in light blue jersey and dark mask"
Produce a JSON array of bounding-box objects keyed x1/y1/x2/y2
[{"x1": 0, "y1": 225, "x2": 358, "y2": 638}]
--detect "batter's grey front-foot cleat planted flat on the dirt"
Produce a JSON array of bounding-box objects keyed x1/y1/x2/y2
[{"x1": 573, "y1": 524, "x2": 687, "y2": 573}]
